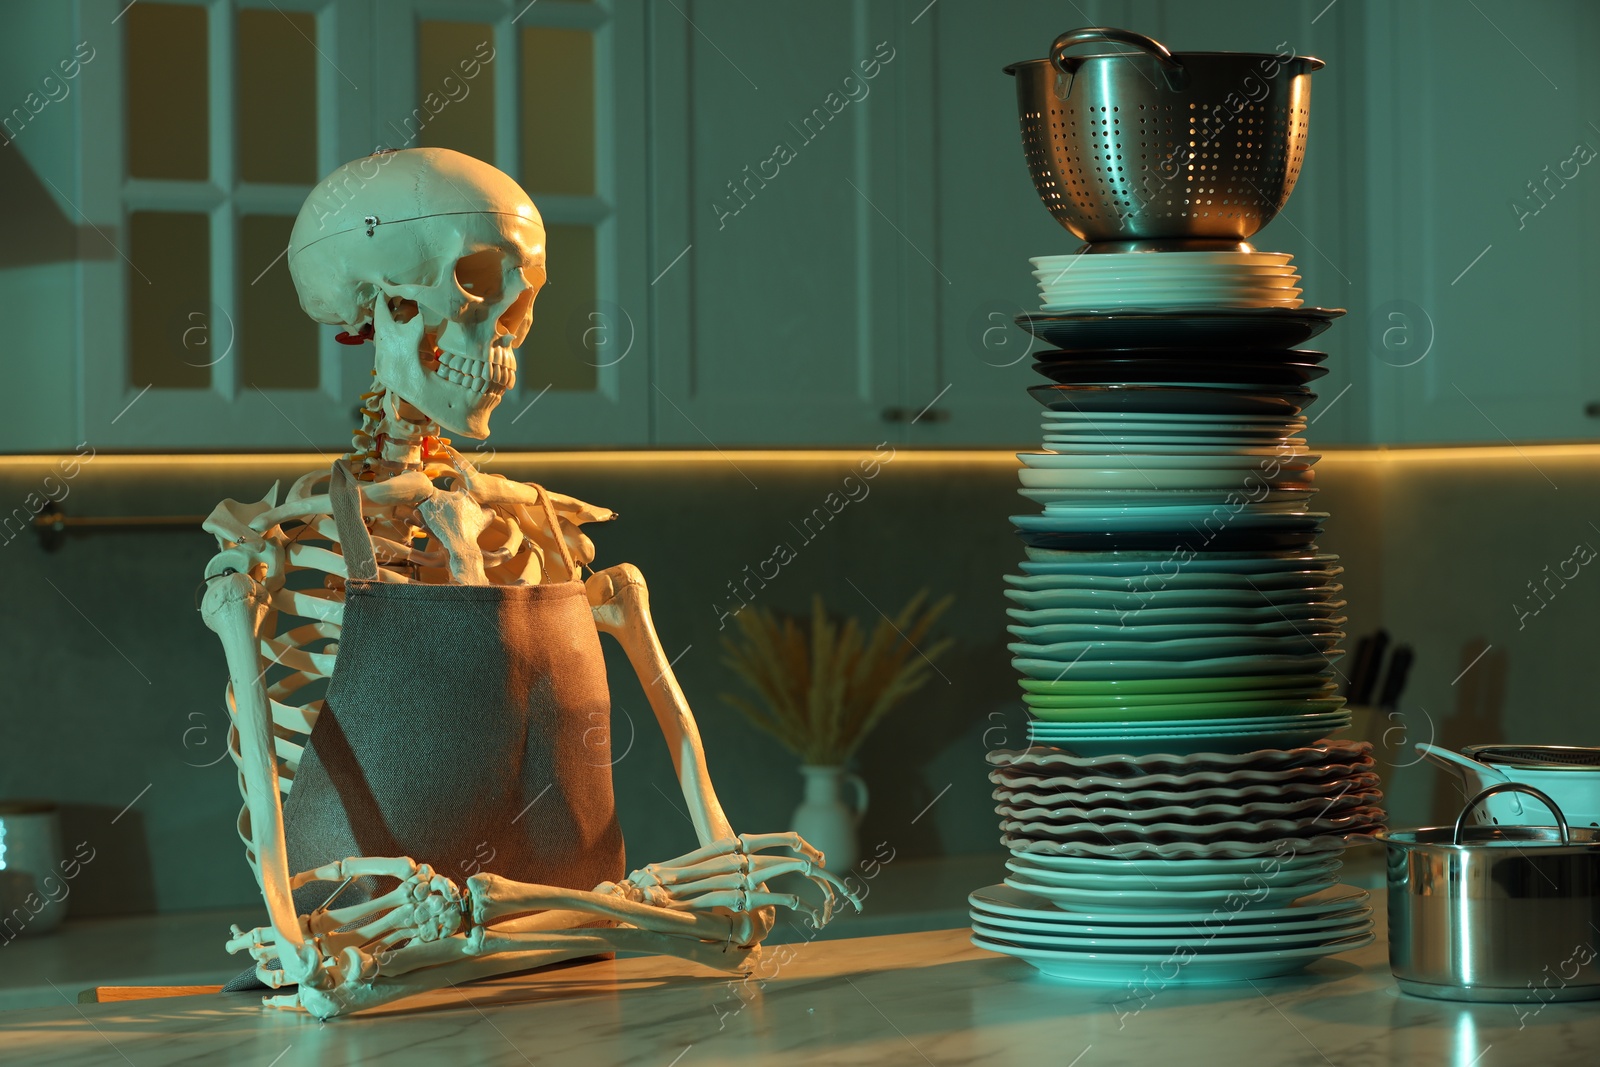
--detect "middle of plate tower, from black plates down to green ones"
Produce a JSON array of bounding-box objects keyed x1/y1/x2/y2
[{"x1": 1005, "y1": 295, "x2": 1350, "y2": 755}]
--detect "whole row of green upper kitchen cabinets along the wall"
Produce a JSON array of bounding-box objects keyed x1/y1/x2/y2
[{"x1": 0, "y1": 0, "x2": 1600, "y2": 453}]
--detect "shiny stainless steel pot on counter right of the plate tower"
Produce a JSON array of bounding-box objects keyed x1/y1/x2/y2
[{"x1": 1378, "y1": 782, "x2": 1600, "y2": 1005}]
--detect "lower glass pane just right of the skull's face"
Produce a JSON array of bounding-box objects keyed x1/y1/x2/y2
[{"x1": 517, "y1": 224, "x2": 598, "y2": 397}]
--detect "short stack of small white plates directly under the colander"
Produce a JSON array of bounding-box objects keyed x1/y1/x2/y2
[{"x1": 1029, "y1": 251, "x2": 1301, "y2": 312}]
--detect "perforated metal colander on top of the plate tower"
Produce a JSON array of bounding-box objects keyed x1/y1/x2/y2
[{"x1": 1005, "y1": 27, "x2": 1323, "y2": 251}]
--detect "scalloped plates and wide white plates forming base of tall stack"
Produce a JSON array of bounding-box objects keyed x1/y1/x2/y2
[{"x1": 968, "y1": 742, "x2": 1382, "y2": 984}]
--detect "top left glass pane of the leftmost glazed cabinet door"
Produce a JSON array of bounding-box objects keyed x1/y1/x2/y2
[{"x1": 122, "y1": 3, "x2": 211, "y2": 181}]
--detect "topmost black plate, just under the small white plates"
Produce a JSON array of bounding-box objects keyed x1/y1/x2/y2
[{"x1": 1016, "y1": 307, "x2": 1344, "y2": 350}]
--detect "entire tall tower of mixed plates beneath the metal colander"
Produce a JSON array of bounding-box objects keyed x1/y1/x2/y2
[{"x1": 970, "y1": 253, "x2": 1384, "y2": 984}]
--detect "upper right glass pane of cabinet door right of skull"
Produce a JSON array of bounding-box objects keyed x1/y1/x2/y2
[{"x1": 522, "y1": 26, "x2": 595, "y2": 198}]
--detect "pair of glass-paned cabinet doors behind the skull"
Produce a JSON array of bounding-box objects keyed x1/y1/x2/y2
[{"x1": 80, "y1": 0, "x2": 648, "y2": 454}]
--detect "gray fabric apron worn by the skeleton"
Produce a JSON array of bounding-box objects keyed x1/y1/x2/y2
[{"x1": 227, "y1": 464, "x2": 626, "y2": 989}]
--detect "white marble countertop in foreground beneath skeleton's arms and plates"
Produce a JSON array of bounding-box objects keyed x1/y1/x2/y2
[{"x1": 0, "y1": 902, "x2": 1600, "y2": 1067}]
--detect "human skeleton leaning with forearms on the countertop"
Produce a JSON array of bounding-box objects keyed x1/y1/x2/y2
[{"x1": 202, "y1": 149, "x2": 859, "y2": 1019}]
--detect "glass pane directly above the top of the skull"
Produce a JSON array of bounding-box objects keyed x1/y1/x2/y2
[{"x1": 412, "y1": 22, "x2": 494, "y2": 163}]
